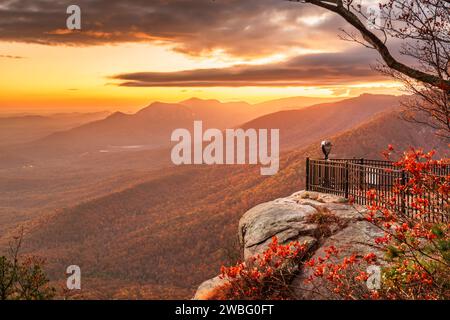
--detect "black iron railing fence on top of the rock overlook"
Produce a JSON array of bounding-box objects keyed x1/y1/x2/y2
[{"x1": 306, "y1": 158, "x2": 450, "y2": 221}]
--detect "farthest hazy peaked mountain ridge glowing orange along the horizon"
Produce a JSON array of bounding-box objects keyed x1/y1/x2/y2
[{"x1": 0, "y1": 97, "x2": 346, "y2": 168}]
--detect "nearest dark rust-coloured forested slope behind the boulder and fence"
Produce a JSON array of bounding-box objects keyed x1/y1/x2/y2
[{"x1": 0, "y1": 97, "x2": 446, "y2": 298}]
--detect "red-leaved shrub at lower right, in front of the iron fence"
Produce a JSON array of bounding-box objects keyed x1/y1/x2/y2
[{"x1": 304, "y1": 146, "x2": 450, "y2": 299}]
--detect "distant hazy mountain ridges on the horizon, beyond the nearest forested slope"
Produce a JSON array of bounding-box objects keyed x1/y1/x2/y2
[{"x1": 0, "y1": 95, "x2": 400, "y2": 162}]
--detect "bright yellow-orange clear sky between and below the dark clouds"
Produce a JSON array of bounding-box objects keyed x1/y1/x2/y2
[{"x1": 0, "y1": 0, "x2": 400, "y2": 113}]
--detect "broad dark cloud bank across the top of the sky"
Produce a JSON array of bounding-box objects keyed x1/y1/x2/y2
[{"x1": 0, "y1": 0, "x2": 343, "y2": 57}]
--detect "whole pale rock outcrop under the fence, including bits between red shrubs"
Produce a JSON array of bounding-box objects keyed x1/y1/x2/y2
[{"x1": 194, "y1": 191, "x2": 382, "y2": 299}]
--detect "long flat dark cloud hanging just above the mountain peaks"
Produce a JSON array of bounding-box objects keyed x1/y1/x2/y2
[{"x1": 112, "y1": 49, "x2": 386, "y2": 87}]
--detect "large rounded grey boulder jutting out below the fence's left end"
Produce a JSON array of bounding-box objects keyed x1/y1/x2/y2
[{"x1": 238, "y1": 191, "x2": 363, "y2": 259}]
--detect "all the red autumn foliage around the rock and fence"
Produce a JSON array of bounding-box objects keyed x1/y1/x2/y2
[{"x1": 215, "y1": 146, "x2": 450, "y2": 300}]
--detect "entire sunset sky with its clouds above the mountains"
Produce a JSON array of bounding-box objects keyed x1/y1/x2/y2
[{"x1": 0, "y1": 0, "x2": 400, "y2": 113}]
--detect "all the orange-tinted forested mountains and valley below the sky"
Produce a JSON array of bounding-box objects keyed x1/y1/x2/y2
[{"x1": 0, "y1": 95, "x2": 447, "y2": 298}]
